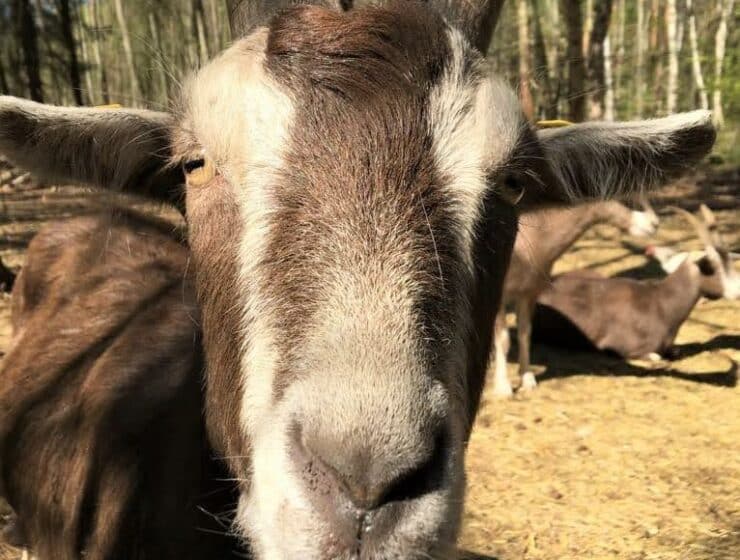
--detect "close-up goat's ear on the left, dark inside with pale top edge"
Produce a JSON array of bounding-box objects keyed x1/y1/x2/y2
[{"x1": 0, "y1": 96, "x2": 184, "y2": 206}]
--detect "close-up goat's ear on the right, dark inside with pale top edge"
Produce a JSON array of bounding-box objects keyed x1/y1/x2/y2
[{"x1": 537, "y1": 111, "x2": 716, "y2": 203}]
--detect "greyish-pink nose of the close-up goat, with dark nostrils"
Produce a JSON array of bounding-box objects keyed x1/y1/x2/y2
[{"x1": 290, "y1": 425, "x2": 446, "y2": 540}]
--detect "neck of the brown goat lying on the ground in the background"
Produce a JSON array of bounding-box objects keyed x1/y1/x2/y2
[{"x1": 655, "y1": 259, "x2": 701, "y2": 330}]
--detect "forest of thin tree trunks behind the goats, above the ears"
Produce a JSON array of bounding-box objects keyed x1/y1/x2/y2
[{"x1": 0, "y1": 0, "x2": 740, "y2": 160}]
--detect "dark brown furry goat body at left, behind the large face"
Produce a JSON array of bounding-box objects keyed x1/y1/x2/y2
[{"x1": 0, "y1": 211, "x2": 238, "y2": 560}]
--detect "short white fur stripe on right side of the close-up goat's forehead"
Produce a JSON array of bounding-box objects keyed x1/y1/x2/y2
[{"x1": 429, "y1": 30, "x2": 525, "y2": 267}]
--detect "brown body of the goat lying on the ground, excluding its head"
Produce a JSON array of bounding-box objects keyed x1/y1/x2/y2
[{"x1": 532, "y1": 263, "x2": 699, "y2": 358}]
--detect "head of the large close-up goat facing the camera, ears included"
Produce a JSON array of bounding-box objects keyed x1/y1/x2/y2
[{"x1": 0, "y1": 0, "x2": 715, "y2": 560}]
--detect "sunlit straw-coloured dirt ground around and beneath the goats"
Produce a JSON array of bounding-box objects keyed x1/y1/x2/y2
[{"x1": 0, "y1": 169, "x2": 740, "y2": 560}]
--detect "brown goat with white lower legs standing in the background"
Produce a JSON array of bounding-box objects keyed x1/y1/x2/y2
[{"x1": 492, "y1": 198, "x2": 658, "y2": 398}]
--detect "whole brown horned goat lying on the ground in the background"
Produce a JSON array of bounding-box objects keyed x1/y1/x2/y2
[{"x1": 533, "y1": 206, "x2": 740, "y2": 360}]
